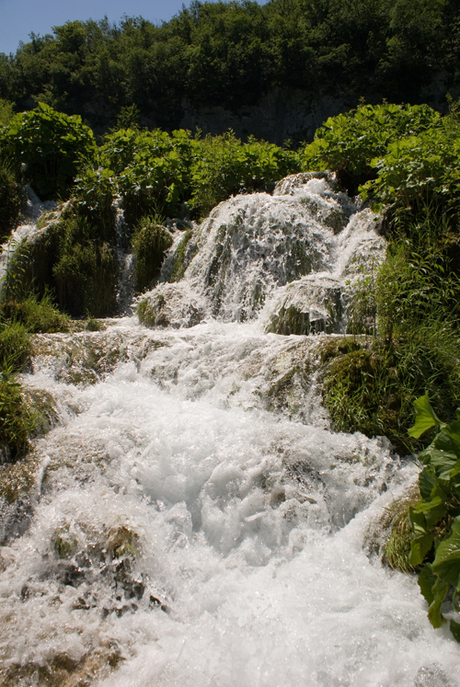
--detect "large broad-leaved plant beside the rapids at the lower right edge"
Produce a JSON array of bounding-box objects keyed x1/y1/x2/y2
[{"x1": 409, "y1": 394, "x2": 460, "y2": 642}]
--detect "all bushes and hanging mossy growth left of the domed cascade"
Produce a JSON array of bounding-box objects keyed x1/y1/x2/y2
[{"x1": 0, "y1": 104, "x2": 300, "y2": 317}]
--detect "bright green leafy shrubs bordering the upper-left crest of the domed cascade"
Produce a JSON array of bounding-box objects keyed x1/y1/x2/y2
[{"x1": 101, "y1": 128, "x2": 300, "y2": 220}]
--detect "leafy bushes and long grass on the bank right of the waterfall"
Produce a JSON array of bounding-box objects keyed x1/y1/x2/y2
[{"x1": 310, "y1": 104, "x2": 460, "y2": 452}]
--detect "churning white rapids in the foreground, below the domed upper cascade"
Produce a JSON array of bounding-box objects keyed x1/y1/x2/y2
[{"x1": 0, "y1": 320, "x2": 460, "y2": 687}]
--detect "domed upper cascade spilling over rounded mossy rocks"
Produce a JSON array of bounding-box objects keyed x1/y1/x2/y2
[{"x1": 138, "y1": 174, "x2": 385, "y2": 334}]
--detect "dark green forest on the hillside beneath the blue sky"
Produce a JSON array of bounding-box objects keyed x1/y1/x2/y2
[{"x1": 0, "y1": 0, "x2": 460, "y2": 133}]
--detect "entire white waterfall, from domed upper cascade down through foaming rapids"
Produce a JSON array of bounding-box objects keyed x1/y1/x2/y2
[{"x1": 0, "y1": 180, "x2": 460, "y2": 687}]
